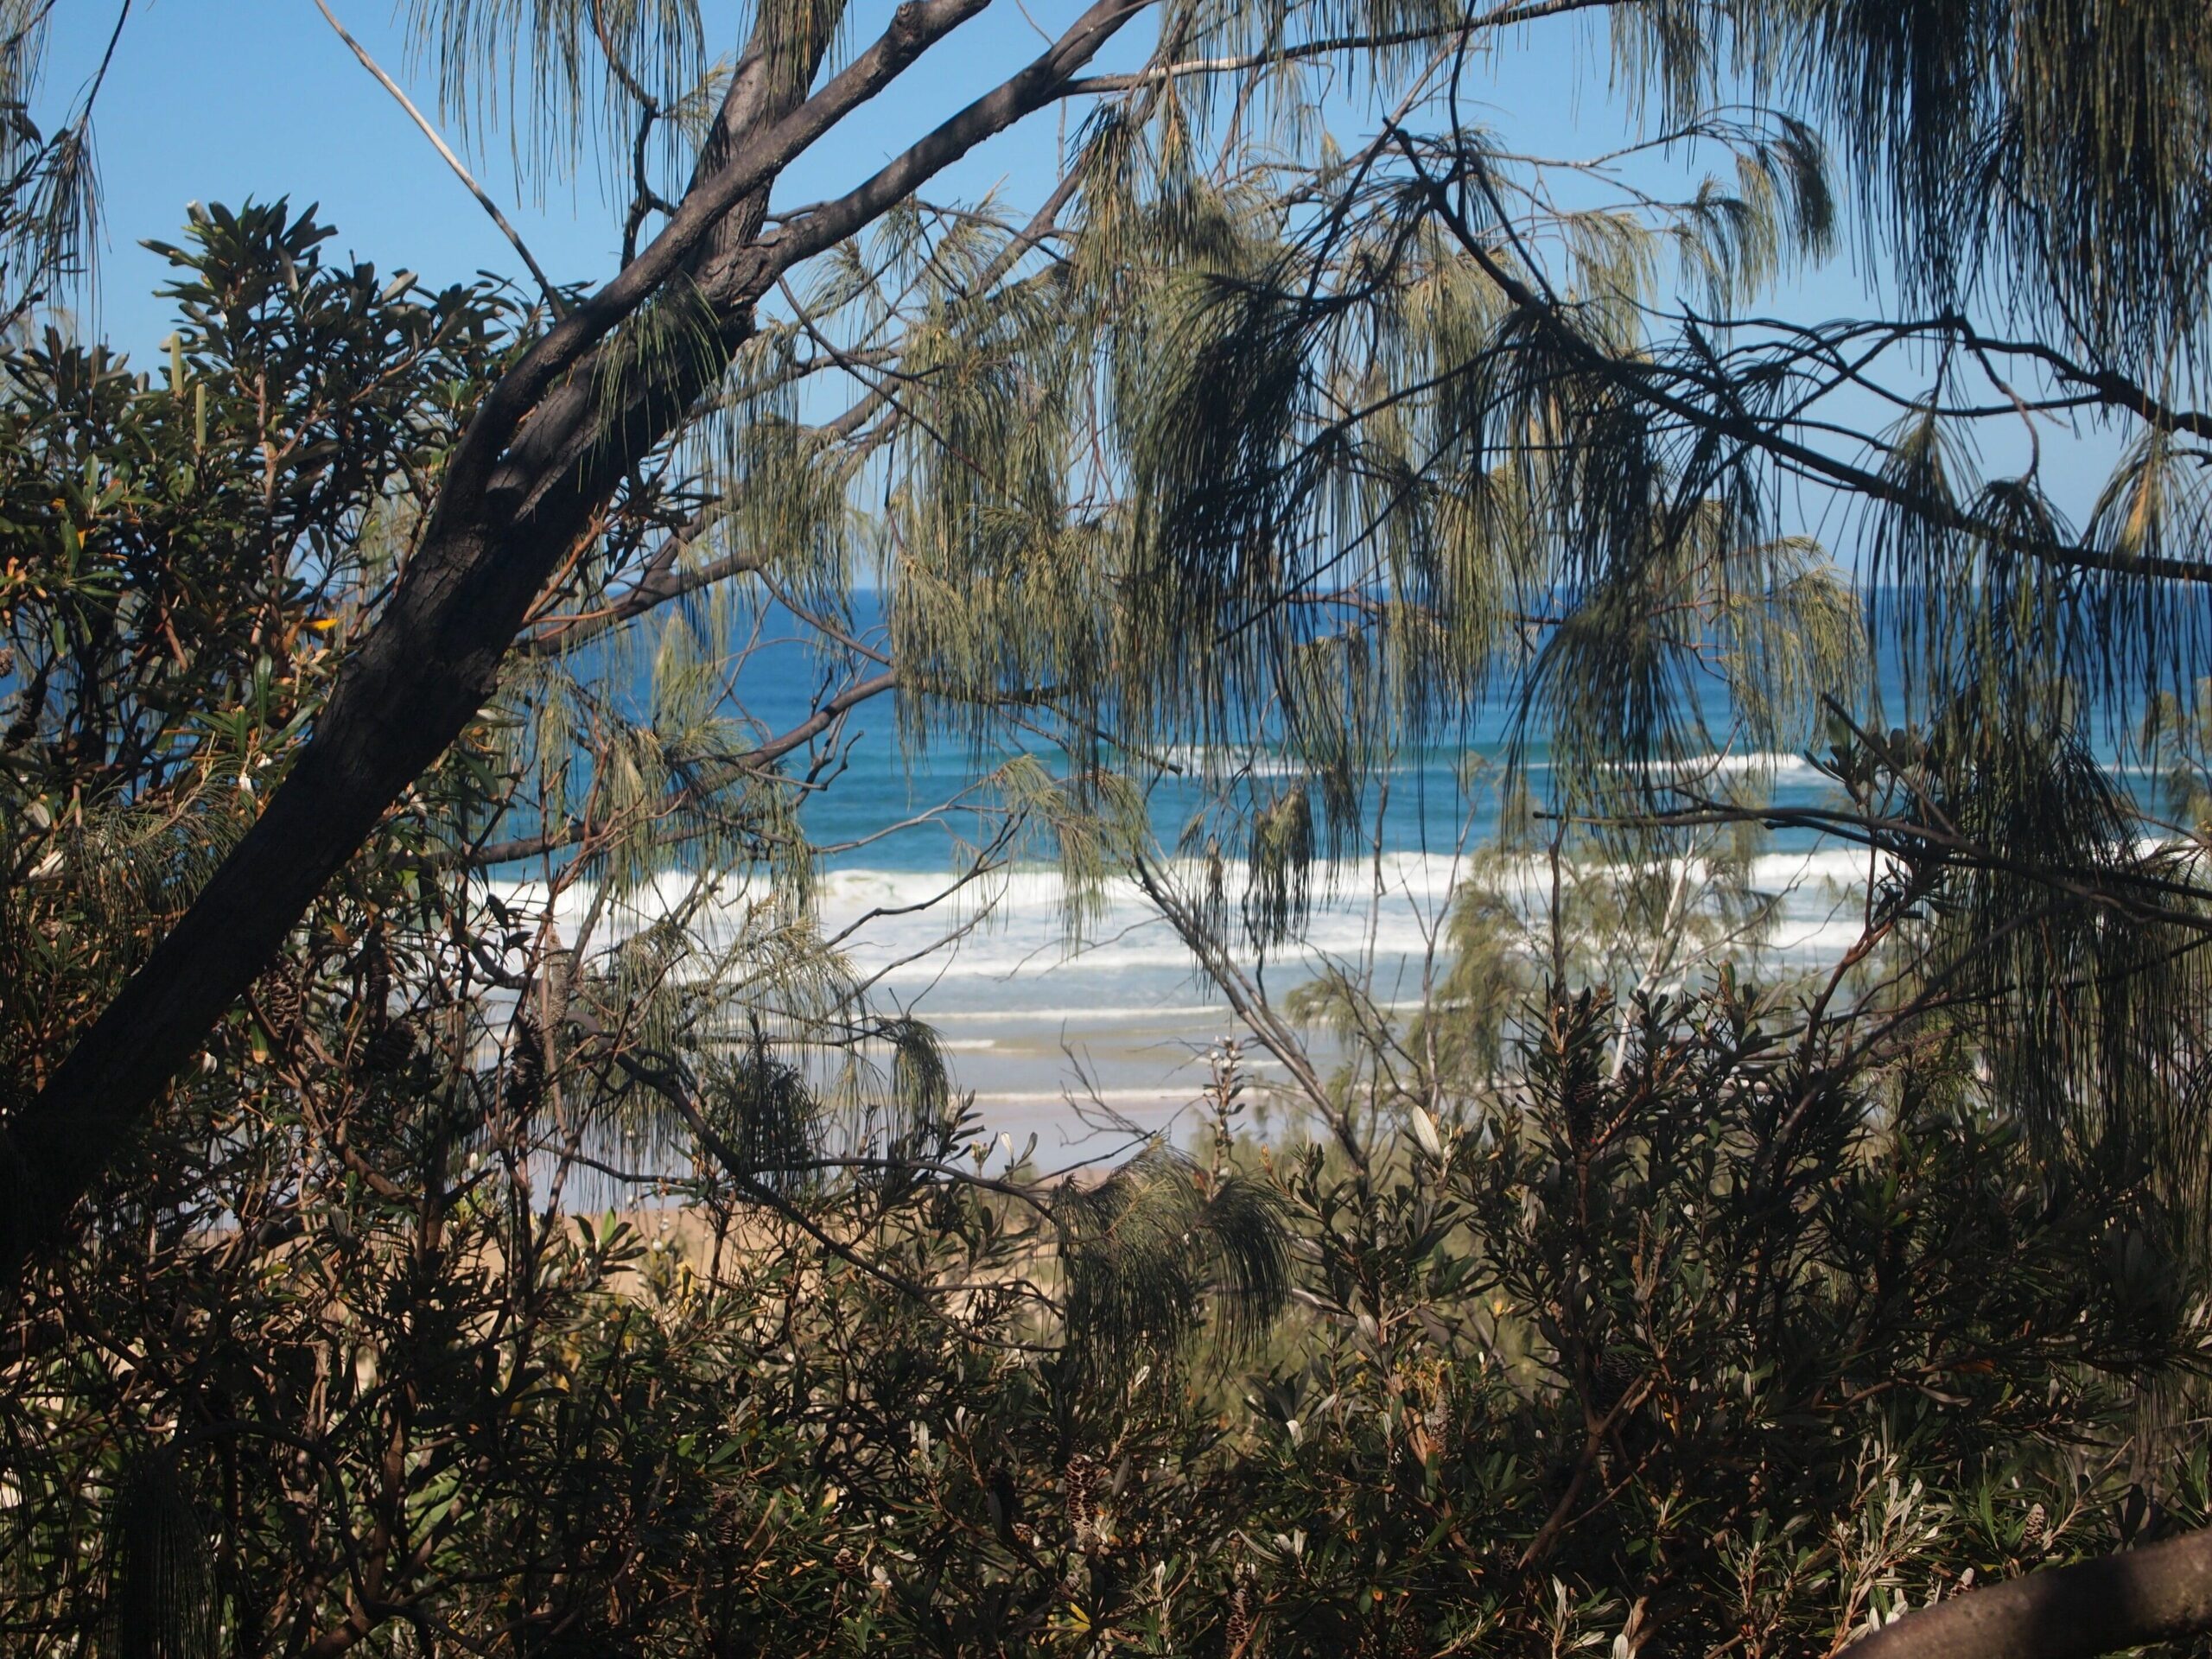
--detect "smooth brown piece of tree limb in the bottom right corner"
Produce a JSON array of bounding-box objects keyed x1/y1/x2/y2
[{"x1": 1845, "y1": 1531, "x2": 2212, "y2": 1659}]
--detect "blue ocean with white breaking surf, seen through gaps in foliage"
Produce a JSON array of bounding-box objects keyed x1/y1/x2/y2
[{"x1": 498, "y1": 595, "x2": 2167, "y2": 1168}]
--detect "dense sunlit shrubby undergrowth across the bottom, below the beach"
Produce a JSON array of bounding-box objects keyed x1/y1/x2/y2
[{"x1": 0, "y1": 960, "x2": 2208, "y2": 1655}]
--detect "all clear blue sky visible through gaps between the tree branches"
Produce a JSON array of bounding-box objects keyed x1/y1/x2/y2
[{"x1": 47, "y1": 0, "x2": 2110, "y2": 533}]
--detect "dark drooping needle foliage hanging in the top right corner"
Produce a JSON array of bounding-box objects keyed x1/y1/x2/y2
[{"x1": 1714, "y1": 0, "x2": 2212, "y2": 374}]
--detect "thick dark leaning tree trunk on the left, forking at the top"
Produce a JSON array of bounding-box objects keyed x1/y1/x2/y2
[{"x1": 0, "y1": 0, "x2": 1153, "y2": 1287}]
